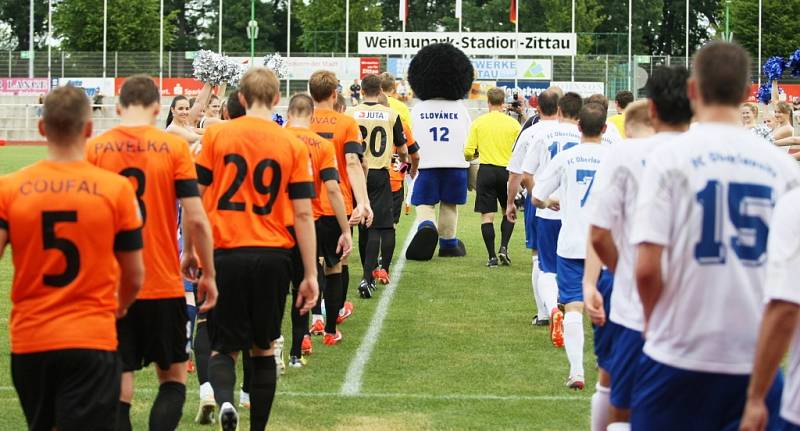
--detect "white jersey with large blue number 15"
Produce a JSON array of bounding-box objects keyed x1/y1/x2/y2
[{"x1": 631, "y1": 123, "x2": 800, "y2": 374}]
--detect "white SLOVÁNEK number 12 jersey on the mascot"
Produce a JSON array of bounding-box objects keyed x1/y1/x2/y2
[{"x1": 411, "y1": 100, "x2": 472, "y2": 169}]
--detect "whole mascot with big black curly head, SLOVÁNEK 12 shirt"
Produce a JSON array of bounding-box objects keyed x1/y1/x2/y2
[{"x1": 406, "y1": 44, "x2": 475, "y2": 260}]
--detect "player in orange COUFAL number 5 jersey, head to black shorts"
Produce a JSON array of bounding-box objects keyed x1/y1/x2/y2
[{"x1": 0, "y1": 86, "x2": 144, "y2": 431}]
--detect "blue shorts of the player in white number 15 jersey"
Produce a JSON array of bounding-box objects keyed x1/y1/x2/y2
[{"x1": 631, "y1": 352, "x2": 783, "y2": 431}]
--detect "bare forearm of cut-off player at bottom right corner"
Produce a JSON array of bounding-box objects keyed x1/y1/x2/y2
[{"x1": 739, "y1": 300, "x2": 800, "y2": 431}]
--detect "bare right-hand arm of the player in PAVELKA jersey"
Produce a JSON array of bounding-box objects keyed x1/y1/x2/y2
[{"x1": 181, "y1": 197, "x2": 217, "y2": 313}]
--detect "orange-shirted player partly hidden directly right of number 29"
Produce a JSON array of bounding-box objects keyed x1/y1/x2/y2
[{"x1": 288, "y1": 94, "x2": 353, "y2": 352}]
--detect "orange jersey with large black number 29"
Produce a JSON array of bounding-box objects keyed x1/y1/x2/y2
[{"x1": 197, "y1": 116, "x2": 314, "y2": 249}]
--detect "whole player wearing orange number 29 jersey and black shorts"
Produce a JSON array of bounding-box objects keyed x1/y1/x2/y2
[{"x1": 197, "y1": 67, "x2": 318, "y2": 430}]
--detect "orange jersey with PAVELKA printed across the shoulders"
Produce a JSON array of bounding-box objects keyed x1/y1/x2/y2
[{"x1": 86, "y1": 126, "x2": 199, "y2": 299}]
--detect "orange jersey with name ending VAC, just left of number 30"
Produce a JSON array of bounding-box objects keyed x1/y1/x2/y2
[{"x1": 311, "y1": 108, "x2": 364, "y2": 216}]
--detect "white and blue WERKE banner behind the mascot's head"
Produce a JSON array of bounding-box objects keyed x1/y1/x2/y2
[{"x1": 387, "y1": 58, "x2": 553, "y2": 81}]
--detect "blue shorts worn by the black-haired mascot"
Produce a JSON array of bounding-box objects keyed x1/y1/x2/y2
[{"x1": 411, "y1": 168, "x2": 467, "y2": 205}]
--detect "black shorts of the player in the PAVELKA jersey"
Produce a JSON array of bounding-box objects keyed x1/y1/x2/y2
[{"x1": 117, "y1": 298, "x2": 191, "y2": 371}]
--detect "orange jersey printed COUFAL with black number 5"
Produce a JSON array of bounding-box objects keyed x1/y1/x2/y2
[{"x1": 0, "y1": 161, "x2": 142, "y2": 354}]
